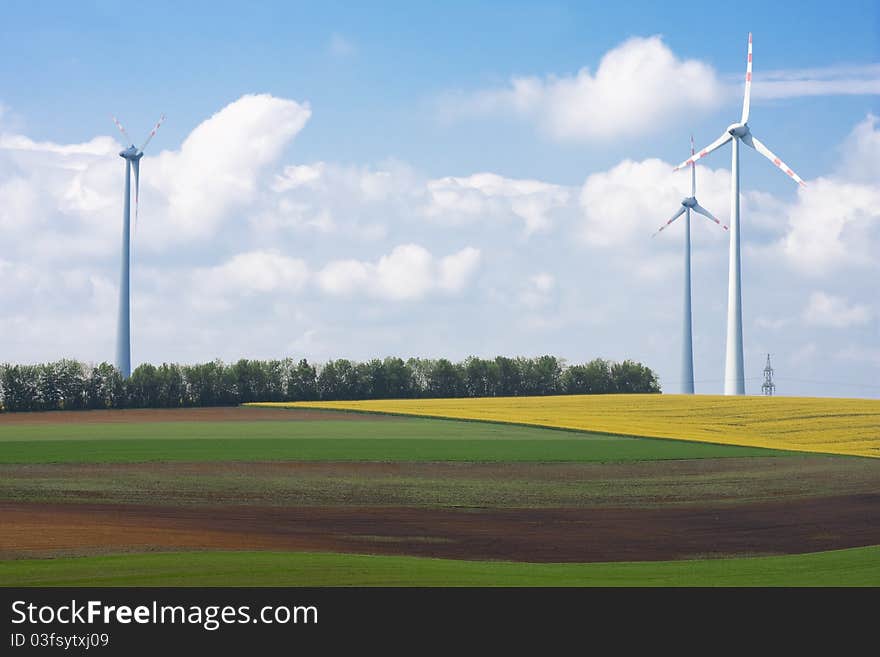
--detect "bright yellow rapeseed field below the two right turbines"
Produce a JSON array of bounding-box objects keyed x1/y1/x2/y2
[{"x1": 253, "y1": 395, "x2": 880, "y2": 458}]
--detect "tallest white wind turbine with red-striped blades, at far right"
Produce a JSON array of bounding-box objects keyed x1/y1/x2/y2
[{"x1": 675, "y1": 32, "x2": 806, "y2": 395}]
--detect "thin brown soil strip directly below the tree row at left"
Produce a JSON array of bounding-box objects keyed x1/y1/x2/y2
[{"x1": 0, "y1": 406, "x2": 384, "y2": 426}]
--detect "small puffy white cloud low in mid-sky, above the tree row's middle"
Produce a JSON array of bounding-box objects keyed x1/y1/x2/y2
[{"x1": 317, "y1": 244, "x2": 480, "y2": 301}]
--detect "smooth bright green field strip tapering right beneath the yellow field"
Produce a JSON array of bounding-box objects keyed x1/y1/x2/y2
[{"x1": 0, "y1": 418, "x2": 790, "y2": 463}]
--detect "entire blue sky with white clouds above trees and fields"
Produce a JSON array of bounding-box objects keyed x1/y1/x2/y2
[{"x1": 0, "y1": 1, "x2": 880, "y2": 396}]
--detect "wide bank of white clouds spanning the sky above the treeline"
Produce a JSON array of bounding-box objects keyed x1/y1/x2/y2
[{"x1": 0, "y1": 89, "x2": 880, "y2": 393}]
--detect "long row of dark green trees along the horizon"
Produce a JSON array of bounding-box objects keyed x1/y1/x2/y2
[{"x1": 0, "y1": 356, "x2": 660, "y2": 412}]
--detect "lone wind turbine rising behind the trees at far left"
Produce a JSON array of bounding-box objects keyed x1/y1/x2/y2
[{"x1": 112, "y1": 114, "x2": 165, "y2": 379}]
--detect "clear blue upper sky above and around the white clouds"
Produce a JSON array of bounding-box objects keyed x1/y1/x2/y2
[{"x1": 0, "y1": 1, "x2": 880, "y2": 177}]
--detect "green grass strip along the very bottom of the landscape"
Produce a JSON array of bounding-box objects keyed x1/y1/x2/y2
[{"x1": 0, "y1": 546, "x2": 880, "y2": 586}]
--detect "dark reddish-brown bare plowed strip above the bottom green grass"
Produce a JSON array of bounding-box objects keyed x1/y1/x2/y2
[{"x1": 0, "y1": 494, "x2": 880, "y2": 562}]
